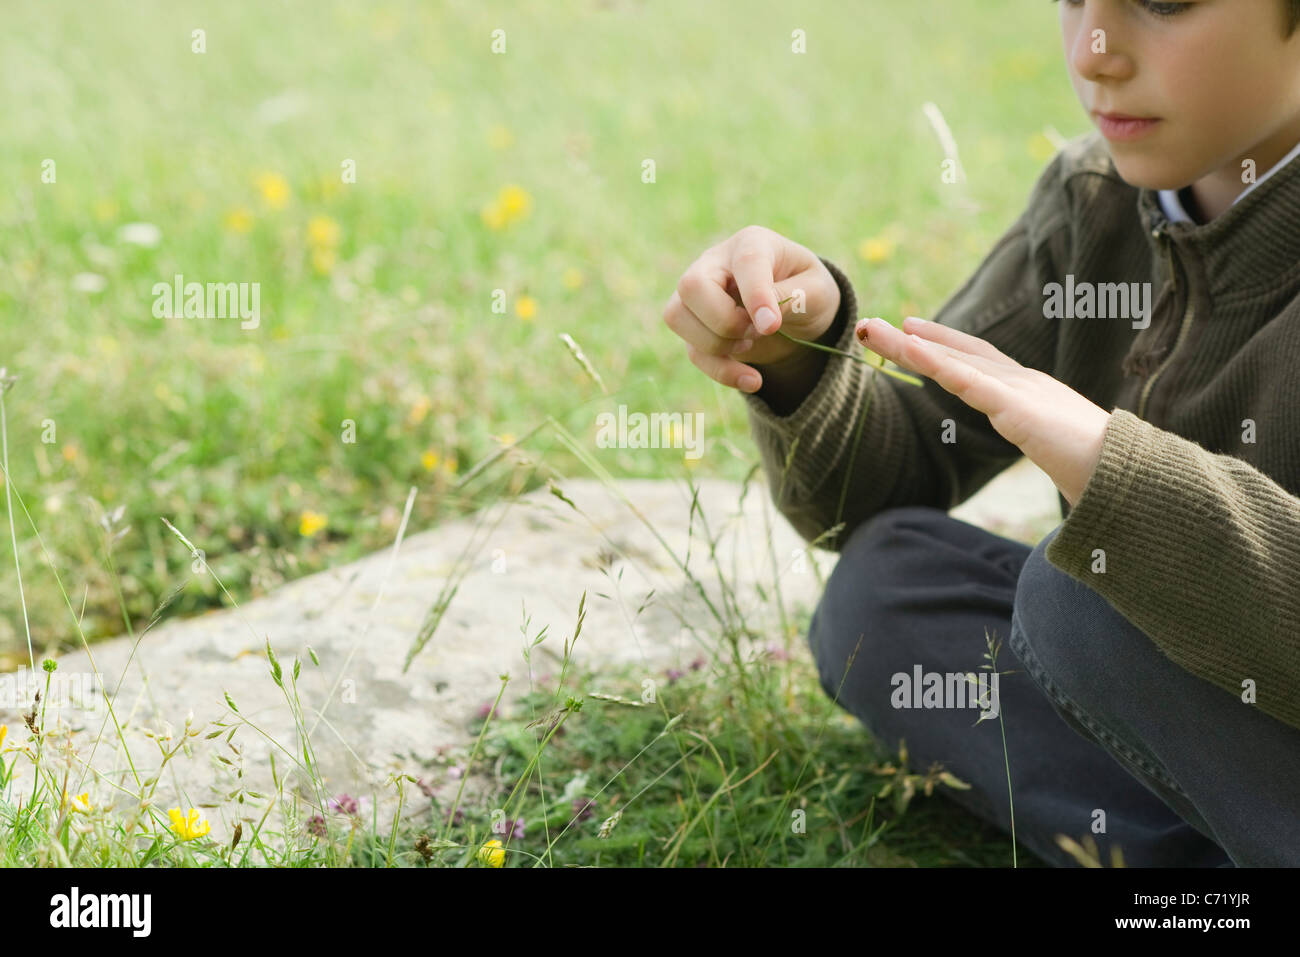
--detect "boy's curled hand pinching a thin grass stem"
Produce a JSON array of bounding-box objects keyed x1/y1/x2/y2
[{"x1": 663, "y1": 226, "x2": 840, "y2": 393}]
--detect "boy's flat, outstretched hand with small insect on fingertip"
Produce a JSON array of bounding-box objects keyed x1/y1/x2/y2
[{"x1": 855, "y1": 316, "x2": 1110, "y2": 507}]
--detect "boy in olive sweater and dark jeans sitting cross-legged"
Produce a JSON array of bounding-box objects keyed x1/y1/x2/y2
[{"x1": 664, "y1": 0, "x2": 1300, "y2": 866}]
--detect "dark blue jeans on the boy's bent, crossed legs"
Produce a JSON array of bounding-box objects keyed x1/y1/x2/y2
[{"x1": 809, "y1": 507, "x2": 1300, "y2": 867}]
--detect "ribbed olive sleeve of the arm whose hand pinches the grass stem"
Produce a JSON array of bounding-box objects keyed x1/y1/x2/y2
[{"x1": 742, "y1": 153, "x2": 1070, "y2": 551}]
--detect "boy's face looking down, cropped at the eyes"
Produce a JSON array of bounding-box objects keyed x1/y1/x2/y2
[{"x1": 1061, "y1": 0, "x2": 1300, "y2": 190}]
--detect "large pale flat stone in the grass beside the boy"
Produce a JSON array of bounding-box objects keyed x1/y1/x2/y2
[{"x1": 0, "y1": 463, "x2": 1060, "y2": 841}]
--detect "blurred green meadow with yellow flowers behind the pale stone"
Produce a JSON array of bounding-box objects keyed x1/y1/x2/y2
[{"x1": 0, "y1": 0, "x2": 1088, "y2": 657}]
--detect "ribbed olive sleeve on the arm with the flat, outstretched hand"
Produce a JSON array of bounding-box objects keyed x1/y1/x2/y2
[{"x1": 1047, "y1": 408, "x2": 1300, "y2": 728}]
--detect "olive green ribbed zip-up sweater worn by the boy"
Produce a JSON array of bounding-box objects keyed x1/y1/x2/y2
[{"x1": 744, "y1": 133, "x2": 1300, "y2": 728}]
